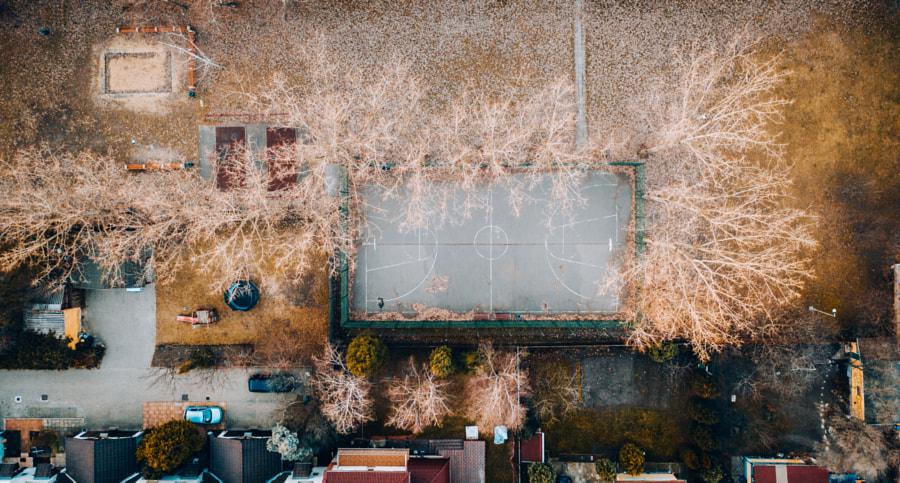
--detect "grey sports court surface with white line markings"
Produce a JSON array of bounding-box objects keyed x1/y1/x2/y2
[{"x1": 351, "y1": 172, "x2": 633, "y2": 318}]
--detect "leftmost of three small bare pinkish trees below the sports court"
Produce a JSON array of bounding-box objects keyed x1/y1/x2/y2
[{"x1": 310, "y1": 344, "x2": 374, "y2": 434}]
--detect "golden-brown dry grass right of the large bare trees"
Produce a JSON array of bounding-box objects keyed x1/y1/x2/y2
[{"x1": 779, "y1": 21, "x2": 900, "y2": 332}]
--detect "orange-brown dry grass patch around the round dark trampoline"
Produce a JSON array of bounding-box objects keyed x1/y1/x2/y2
[{"x1": 156, "y1": 246, "x2": 329, "y2": 358}]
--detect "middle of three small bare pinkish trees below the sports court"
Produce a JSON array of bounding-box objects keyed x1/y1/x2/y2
[{"x1": 386, "y1": 357, "x2": 450, "y2": 434}]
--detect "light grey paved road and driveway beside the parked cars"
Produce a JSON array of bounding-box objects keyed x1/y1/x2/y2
[{"x1": 0, "y1": 285, "x2": 305, "y2": 429}]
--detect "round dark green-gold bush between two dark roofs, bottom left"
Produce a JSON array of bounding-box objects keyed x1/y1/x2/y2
[{"x1": 137, "y1": 419, "x2": 203, "y2": 474}]
